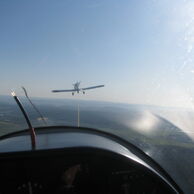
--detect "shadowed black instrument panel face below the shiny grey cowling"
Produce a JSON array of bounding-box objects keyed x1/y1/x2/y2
[{"x1": 0, "y1": 149, "x2": 176, "y2": 194}]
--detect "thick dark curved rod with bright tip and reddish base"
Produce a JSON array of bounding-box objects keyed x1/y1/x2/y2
[{"x1": 11, "y1": 91, "x2": 36, "y2": 150}]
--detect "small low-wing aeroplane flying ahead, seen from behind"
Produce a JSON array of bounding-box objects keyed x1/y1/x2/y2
[{"x1": 52, "y1": 82, "x2": 104, "y2": 95}]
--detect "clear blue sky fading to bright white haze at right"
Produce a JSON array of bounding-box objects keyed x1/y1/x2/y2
[{"x1": 0, "y1": 0, "x2": 194, "y2": 108}]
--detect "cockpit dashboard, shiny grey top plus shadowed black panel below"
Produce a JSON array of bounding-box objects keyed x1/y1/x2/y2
[{"x1": 0, "y1": 128, "x2": 180, "y2": 194}]
